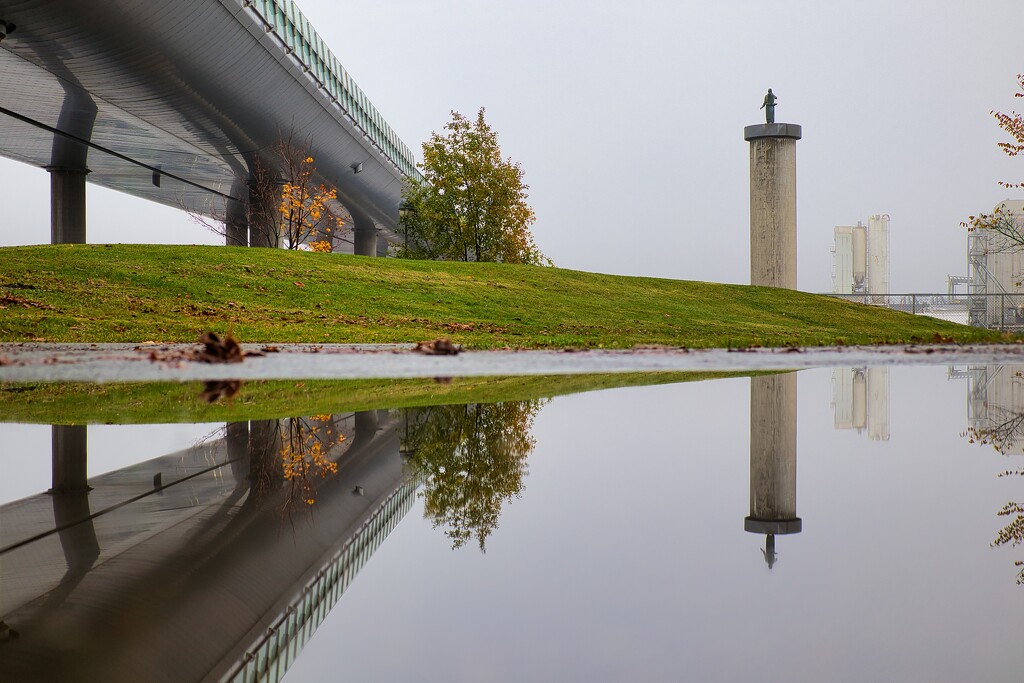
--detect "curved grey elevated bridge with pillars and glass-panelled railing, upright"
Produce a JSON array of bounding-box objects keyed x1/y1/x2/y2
[{"x1": 0, "y1": 0, "x2": 418, "y2": 255}]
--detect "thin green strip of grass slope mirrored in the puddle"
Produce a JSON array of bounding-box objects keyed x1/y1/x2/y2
[{"x1": 0, "y1": 373, "x2": 757, "y2": 424}]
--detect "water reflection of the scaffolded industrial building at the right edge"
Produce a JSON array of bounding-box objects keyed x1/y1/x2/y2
[{"x1": 949, "y1": 366, "x2": 1024, "y2": 455}]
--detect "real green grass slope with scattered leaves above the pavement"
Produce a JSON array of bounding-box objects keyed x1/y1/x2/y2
[{"x1": 0, "y1": 245, "x2": 1005, "y2": 348}]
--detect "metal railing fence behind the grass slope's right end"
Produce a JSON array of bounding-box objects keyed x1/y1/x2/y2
[{"x1": 825, "y1": 292, "x2": 1024, "y2": 331}]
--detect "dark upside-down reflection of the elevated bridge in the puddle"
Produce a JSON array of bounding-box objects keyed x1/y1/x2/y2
[{"x1": 0, "y1": 413, "x2": 416, "y2": 682}]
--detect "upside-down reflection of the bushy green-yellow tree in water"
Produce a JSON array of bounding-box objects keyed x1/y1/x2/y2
[{"x1": 403, "y1": 400, "x2": 544, "y2": 552}]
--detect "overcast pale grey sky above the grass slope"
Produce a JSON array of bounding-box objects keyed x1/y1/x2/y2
[{"x1": 0, "y1": 0, "x2": 1024, "y2": 292}]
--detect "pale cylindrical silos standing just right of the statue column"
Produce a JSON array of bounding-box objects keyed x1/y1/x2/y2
[{"x1": 833, "y1": 214, "x2": 889, "y2": 303}]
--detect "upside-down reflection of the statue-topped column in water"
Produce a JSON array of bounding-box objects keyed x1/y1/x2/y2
[{"x1": 743, "y1": 373, "x2": 802, "y2": 567}]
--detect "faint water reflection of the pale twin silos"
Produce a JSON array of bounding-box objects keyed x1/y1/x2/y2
[{"x1": 833, "y1": 367, "x2": 889, "y2": 441}]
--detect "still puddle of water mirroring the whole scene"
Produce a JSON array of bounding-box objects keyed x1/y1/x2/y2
[{"x1": 0, "y1": 366, "x2": 1024, "y2": 681}]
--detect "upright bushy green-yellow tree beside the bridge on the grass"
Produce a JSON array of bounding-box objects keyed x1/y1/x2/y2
[{"x1": 398, "y1": 109, "x2": 550, "y2": 264}]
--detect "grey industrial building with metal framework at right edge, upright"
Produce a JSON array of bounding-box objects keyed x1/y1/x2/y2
[{"x1": 967, "y1": 200, "x2": 1024, "y2": 329}]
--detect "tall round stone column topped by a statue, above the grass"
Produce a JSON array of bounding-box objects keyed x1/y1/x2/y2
[{"x1": 743, "y1": 88, "x2": 802, "y2": 290}]
